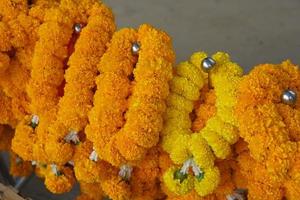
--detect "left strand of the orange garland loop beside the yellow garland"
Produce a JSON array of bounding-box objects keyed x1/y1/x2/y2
[{"x1": 85, "y1": 29, "x2": 137, "y2": 166}]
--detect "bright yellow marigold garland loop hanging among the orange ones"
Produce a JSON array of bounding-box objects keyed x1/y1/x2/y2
[{"x1": 162, "y1": 52, "x2": 242, "y2": 196}]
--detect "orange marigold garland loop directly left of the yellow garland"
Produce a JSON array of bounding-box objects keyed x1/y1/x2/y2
[{"x1": 86, "y1": 25, "x2": 174, "y2": 166}]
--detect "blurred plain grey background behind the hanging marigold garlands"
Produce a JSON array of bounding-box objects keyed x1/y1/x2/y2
[{"x1": 0, "y1": 0, "x2": 300, "y2": 200}]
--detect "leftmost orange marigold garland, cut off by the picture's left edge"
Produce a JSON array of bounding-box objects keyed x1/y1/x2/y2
[{"x1": 0, "y1": 0, "x2": 54, "y2": 120}]
